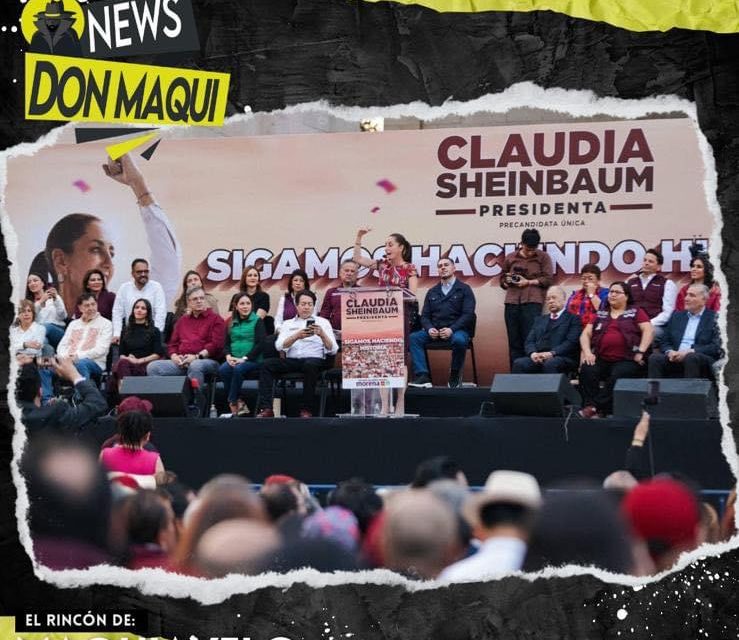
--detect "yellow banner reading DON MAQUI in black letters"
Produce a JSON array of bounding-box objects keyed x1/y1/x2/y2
[{"x1": 25, "y1": 53, "x2": 230, "y2": 127}]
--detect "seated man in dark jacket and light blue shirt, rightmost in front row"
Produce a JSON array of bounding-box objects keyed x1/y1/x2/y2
[{"x1": 649, "y1": 284, "x2": 721, "y2": 378}]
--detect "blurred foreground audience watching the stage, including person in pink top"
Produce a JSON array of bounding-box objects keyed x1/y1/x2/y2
[{"x1": 22, "y1": 404, "x2": 735, "y2": 583}]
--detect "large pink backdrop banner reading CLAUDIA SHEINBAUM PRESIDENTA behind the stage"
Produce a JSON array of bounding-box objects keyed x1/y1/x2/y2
[{"x1": 5, "y1": 117, "x2": 715, "y2": 385}]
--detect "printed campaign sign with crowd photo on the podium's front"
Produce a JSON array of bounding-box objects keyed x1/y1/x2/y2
[{"x1": 341, "y1": 289, "x2": 406, "y2": 389}]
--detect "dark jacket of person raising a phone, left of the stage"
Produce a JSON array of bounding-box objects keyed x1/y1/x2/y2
[{"x1": 21, "y1": 380, "x2": 108, "y2": 434}]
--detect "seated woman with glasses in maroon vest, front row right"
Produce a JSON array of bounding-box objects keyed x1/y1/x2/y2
[{"x1": 580, "y1": 281, "x2": 654, "y2": 418}]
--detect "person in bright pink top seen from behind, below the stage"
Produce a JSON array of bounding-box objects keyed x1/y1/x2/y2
[{"x1": 100, "y1": 411, "x2": 164, "y2": 488}]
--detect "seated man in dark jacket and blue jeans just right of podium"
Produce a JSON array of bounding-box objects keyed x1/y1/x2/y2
[{"x1": 410, "y1": 258, "x2": 475, "y2": 387}]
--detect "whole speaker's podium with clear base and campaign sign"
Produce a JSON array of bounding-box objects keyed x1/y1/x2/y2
[{"x1": 334, "y1": 287, "x2": 416, "y2": 417}]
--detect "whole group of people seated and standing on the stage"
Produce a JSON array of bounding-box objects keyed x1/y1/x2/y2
[{"x1": 11, "y1": 221, "x2": 723, "y2": 418}]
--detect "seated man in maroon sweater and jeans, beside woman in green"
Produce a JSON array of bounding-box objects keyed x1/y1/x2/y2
[{"x1": 146, "y1": 287, "x2": 226, "y2": 387}]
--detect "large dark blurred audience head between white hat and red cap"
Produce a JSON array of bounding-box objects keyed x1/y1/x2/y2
[{"x1": 523, "y1": 487, "x2": 634, "y2": 573}]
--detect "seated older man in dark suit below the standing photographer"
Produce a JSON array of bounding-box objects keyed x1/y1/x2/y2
[{"x1": 512, "y1": 286, "x2": 582, "y2": 373}]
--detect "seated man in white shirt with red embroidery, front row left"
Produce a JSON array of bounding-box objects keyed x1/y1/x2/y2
[{"x1": 56, "y1": 293, "x2": 113, "y2": 380}]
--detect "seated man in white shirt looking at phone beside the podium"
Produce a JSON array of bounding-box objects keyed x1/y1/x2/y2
[{"x1": 257, "y1": 290, "x2": 339, "y2": 418}]
